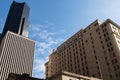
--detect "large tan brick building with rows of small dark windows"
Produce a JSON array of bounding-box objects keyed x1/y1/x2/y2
[{"x1": 45, "y1": 19, "x2": 120, "y2": 80}]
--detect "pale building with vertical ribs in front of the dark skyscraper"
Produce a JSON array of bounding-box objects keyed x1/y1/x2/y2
[{"x1": 0, "y1": 31, "x2": 35, "y2": 80}]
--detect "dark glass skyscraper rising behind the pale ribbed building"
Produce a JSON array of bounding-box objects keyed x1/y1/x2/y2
[{"x1": 2, "y1": 1, "x2": 30, "y2": 38}]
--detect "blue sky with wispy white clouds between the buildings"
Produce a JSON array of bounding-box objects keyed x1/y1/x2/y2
[{"x1": 0, "y1": 0, "x2": 120, "y2": 78}]
